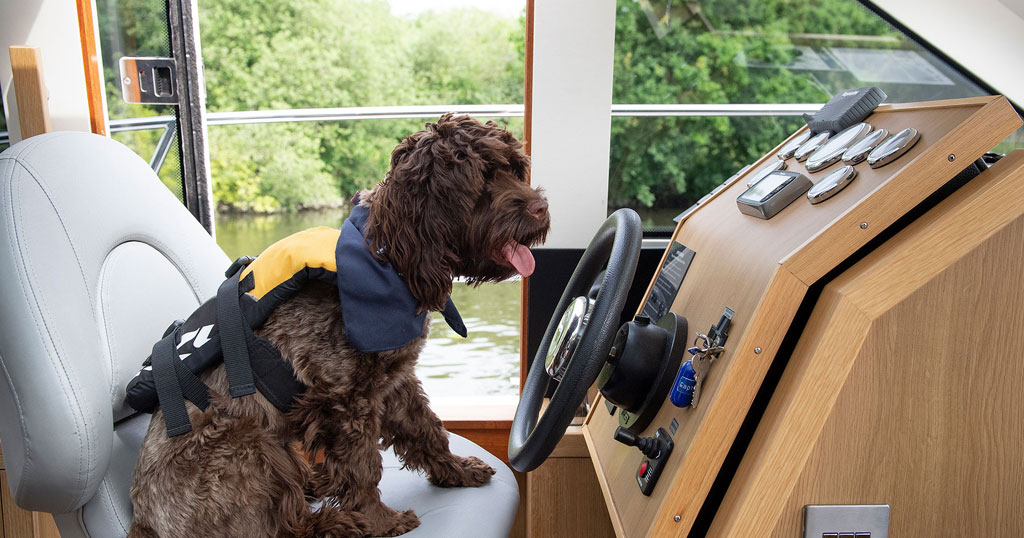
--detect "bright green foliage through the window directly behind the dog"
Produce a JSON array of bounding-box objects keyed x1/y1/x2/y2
[{"x1": 194, "y1": 0, "x2": 523, "y2": 211}]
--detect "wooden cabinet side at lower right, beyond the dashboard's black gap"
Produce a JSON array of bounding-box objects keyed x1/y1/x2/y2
[{"x1": 710, "y1": 151, "x2": 1024, "y2": 537}]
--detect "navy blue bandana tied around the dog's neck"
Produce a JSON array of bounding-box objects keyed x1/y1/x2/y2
[{"x1": 335, "y1": 204, "x2": 467, "y2": 353}]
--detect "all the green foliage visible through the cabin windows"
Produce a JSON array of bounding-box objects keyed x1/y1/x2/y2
[{"x1": 97, "y1": 0, "x2": 987, "y2": 220}]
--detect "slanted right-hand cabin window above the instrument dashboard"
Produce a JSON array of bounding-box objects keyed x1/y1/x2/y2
[{"x1": 608, "y1": 0, "x2": 1024, "y2": 234}]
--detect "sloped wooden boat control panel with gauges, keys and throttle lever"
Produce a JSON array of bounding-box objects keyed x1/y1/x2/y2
[{"x1": 584, "y1": 93, "x2": 1020, "y2": 538}]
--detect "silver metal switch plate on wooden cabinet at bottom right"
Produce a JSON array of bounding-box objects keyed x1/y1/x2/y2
[{"x1": 804, "y1": 504, "x2": 889, "y2": 538}]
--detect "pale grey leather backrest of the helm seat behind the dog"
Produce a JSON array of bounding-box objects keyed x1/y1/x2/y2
[{"x1": 0, "y1": 132, "x2": 228, "y2": 537}]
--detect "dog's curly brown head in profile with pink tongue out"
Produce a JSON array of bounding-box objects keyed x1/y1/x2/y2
[{"x1": 360, "y1": 114, "x2": 550, "y2": 311}]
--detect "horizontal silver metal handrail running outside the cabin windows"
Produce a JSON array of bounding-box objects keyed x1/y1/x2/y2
[{"x1": 0, "y1": 104, "x2": 821, "y2": 143}]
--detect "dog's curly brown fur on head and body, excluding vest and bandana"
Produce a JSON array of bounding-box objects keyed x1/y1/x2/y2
[{"x1": 129, "y1": 115, "x2": 549, "y2": 538}]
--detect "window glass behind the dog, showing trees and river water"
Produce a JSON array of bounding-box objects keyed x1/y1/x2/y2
[{"x1": 199, "y1": 0, "x2": 525, "y2": 397}]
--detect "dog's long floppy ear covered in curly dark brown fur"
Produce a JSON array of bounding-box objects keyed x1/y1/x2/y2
[{"x1": 367, "y1": 124, "x2": 483, "y2": 312}]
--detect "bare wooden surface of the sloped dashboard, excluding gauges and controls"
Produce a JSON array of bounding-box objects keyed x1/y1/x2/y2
[{"x1": 584, "y1": 96, "x2": 1021, "y2": 538}]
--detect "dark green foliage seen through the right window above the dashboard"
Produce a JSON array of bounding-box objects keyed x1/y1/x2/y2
[{"x1": 608, "y1": 0, "x2": 889, "y2": 212}]
